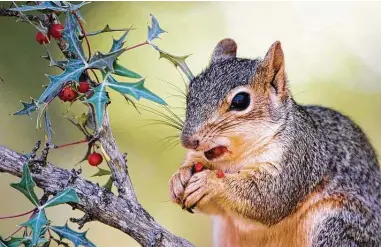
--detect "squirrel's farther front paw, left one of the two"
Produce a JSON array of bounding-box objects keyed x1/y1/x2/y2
[{"x1": 169, "y1": 166, "x2": 193, "y2": 205}]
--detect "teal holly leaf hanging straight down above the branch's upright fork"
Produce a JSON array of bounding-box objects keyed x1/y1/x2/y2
[{"x1": 83, "y1": 83, "x2": 110, "y2": 129}]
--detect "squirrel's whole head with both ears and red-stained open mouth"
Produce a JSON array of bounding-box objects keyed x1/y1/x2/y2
[{"x1": 181, "y1": 39, "x2": 290, "y2": 169}]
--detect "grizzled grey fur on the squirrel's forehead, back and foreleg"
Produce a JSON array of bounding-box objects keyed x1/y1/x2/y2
[{"x1": 182, "y1": 44, "x2": 381, "y2": 247}]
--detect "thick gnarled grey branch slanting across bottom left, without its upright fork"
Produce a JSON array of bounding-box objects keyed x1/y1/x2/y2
[{"x1": 0, "y1": 145, "x2": 193, "y2": 247}]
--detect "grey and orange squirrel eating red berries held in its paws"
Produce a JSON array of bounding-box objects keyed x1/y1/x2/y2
[{"x1": 169, "y1": 39, "x2": 381, "y2": 247}]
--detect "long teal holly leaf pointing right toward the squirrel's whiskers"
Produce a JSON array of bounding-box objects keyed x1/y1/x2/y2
[{"x1": 104, "y1": 75, "x2": 167, "y2": 105}]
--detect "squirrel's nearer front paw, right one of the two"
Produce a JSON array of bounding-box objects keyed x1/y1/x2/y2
[{"x1": 183, "y1": 170, "x2": 221, "y2": 211}]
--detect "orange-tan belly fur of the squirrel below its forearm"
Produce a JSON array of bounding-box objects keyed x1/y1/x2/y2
[{"x1": 214, "y1": 179, "x2": 345, "y2": 247}]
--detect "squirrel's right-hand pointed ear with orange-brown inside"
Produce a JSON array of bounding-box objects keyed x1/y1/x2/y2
[{"x1": 261, "y1": 41, "x2": 288, "y2": 98}]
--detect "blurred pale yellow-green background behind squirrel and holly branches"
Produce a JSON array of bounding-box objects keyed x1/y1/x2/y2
[{"x1": 0, "y1": 2, "x2": 381, "y2": 247}]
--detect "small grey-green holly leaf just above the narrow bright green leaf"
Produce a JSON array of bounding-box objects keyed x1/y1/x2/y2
[{"x1": 87, "y1": 49, "x2": 126, "y2": 71}]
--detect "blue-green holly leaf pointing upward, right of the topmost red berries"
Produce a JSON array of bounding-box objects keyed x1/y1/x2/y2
[{"x1": 62, "y1": 10, "x2": 86, "y2": 64}]
